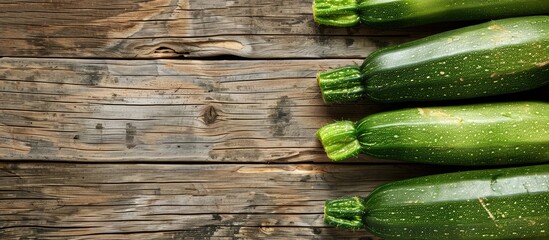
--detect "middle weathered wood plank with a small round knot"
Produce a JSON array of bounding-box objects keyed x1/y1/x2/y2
[{"x1": 0, "y1": 58, "x2": 398, "y2": 162}]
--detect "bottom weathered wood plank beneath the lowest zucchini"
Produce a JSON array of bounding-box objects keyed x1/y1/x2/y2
[{"x1": 0, "y1": 163, "x2": 455, "y2": 239}]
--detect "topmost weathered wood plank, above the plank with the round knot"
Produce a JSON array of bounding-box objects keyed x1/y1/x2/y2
[{"x1": 0, "y1": 0, "x2": 450, "y2": 58}]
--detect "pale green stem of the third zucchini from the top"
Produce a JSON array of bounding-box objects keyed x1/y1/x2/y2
[{"x1": 316, "y1": 121, "x2": 362, "y2": 161}]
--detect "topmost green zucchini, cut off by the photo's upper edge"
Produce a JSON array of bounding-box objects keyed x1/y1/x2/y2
[{"x1": 313, "y1": 0, "x2": 549, "y2": 28}]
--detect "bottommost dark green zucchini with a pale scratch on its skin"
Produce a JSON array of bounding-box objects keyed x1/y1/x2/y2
[{"x1": 324, "y1": 165, "x2": 549, "y2": 240}]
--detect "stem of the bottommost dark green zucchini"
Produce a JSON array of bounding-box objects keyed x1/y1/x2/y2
[{"x1": 324, "y1": 196, "x2": 366, "y2": 230}]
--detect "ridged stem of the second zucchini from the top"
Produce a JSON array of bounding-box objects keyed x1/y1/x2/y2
[{"x1": 317, "y1": 66, "x2": 366, "y2": 104}]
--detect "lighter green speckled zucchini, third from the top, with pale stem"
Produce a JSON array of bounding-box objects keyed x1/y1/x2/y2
[{"x1": 317, "y1": 102, "x2": 549, "y2": 165}]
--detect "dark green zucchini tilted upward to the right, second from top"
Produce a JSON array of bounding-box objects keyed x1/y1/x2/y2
[{"x1": 317, "y1": 15, "x2": 549, "y2": 103}]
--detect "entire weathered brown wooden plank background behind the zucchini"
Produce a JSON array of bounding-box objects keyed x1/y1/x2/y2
[{"x1": 0, "y1": 0, "x2": 544, "y2": 239}]
